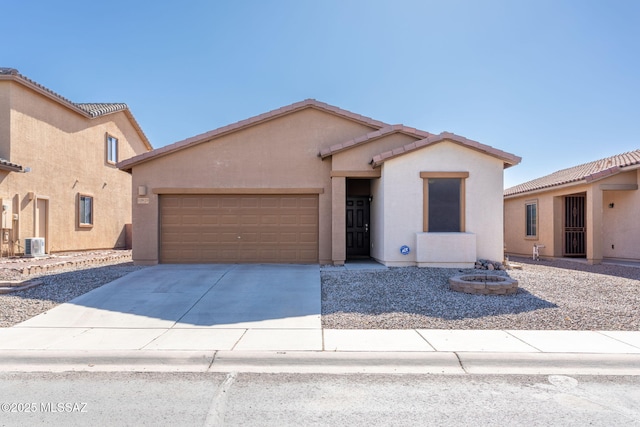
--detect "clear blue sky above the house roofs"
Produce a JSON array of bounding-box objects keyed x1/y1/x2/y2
[{"x1": 0, "y1": 0, "x2": 640, "y2": 187}]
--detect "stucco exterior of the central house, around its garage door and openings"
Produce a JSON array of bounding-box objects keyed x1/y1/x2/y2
[{"x1": 119, "y1": 100, "x2": 519, "y2": 266}]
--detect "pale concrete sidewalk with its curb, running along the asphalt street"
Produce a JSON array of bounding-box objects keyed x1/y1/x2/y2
[{"x1": 0, "y1": 327, "x2": 640, "y2": 375}]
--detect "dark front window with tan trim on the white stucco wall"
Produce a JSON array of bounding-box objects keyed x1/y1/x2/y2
[{"x1": 420, "y1": 172, "x2": 469, "y2": 233}]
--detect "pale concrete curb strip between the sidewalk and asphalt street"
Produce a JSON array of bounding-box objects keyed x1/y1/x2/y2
[{"x1": 0, "y1": 350, "x2": 640, "y2": 376}]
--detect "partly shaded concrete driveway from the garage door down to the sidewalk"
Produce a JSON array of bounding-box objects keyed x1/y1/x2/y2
[{"x1": 19, "y1": 264, "x2": 321, "y2": 329}]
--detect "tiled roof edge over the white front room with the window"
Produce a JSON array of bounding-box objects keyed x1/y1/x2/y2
[{"x1": 371, "y1": 132, "x2": 522, "y2": 168}]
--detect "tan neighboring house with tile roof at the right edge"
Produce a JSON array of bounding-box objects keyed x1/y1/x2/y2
[{"x1": 504, "y1": 150, "x2": 640, "y2": 264}]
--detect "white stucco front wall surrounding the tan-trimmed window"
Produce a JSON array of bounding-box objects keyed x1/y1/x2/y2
[{"x1": 374, "y1": 141, "x2": 503, "y2": 267}]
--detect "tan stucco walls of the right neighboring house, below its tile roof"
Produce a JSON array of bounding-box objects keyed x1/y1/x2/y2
[{"x1": 504, "y1": 167, "x2": 640, "y2": 264}]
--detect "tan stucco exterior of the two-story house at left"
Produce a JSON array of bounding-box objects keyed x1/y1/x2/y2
[{"x1": 0, "y1": 74, "x2": 151, "y2": 255}]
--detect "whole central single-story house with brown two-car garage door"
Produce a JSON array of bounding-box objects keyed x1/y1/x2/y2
[{"x1": 118, "y1": 99, "x2": 520, "y2": 267}]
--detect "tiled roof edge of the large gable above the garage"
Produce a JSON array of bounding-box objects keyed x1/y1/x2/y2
[{"x1": 118, "y1": 99, "x2": 389, "y2": 170}]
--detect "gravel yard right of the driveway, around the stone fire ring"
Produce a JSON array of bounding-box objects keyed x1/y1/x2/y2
[{"x1": 322, "y1": 259, "x2": 640, "y2": 331}]
